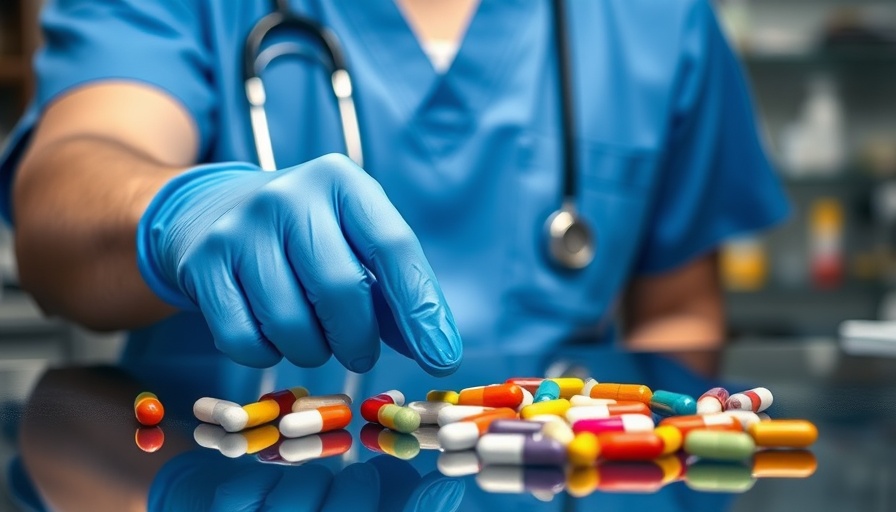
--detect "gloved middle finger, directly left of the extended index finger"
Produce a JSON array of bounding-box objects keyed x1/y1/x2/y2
[{"x1": 286, "y1": 199, "x2": 380, "y2": 372}]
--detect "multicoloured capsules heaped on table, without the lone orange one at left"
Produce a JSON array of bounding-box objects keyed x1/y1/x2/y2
[{"x1": 193, "y1": 378, "x2": 818, "y2": 496}]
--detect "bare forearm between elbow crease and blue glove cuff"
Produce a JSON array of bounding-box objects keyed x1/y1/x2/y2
[{"x1": 13, "y1": 136, "x2": 180, "y2": 330}]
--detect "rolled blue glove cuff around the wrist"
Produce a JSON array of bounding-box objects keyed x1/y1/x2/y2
[{"x1": 137, "y1": 162, "x2": 261, "y2": 311}]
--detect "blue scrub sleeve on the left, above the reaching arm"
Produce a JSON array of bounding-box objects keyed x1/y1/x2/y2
[{"x1": 0, "y1": 0, "x2": 216, "y2": 222}]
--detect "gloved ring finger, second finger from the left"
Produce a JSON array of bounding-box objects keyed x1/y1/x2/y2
[{"x1": 239, "y1": 244, "x2": 330, "y2": 368}]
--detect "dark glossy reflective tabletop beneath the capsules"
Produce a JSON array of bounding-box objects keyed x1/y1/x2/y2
[{"x1": 0, "y1": 342, "x2": 896, "y2": 512}]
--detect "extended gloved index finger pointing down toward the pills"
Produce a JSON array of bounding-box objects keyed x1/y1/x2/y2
[{"x1": 339, "y1": 179, "x2": 463, "y2": 376}]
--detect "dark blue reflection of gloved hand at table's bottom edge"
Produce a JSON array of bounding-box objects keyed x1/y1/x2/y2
[{"x1": 147, "y1": 449, "x2": 466, "y2": 512}]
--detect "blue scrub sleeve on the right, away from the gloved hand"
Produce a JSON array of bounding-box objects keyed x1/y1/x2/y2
[{"x1": 635, "y1": 0, "x2": 789, "y2": 275}]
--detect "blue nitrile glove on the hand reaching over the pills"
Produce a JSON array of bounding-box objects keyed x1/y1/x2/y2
[{"x1": 137, "y1": 155, "x2": 463, "y2": 376}]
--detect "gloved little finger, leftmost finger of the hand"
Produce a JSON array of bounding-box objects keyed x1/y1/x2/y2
[{"x1": 183, "y1": 233, "x2": 282, "y2": 368}]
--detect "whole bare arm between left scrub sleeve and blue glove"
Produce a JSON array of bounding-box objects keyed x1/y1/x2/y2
[{"x1": 12, "y1": 82, "x2": 192, "y2": 329}]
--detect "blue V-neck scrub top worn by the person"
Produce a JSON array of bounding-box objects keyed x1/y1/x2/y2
[{"x1": 0, "y1": 0, "x2": 788, "y2": 400}]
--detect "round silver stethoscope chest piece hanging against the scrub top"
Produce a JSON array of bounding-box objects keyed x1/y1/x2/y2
[{"x1": 545, "y1": 204, "x2": 597, "y2": 270}]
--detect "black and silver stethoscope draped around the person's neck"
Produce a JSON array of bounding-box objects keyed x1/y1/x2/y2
[{"x1": 243, "y1": 0, "x2": 597, "y2": 270}]
